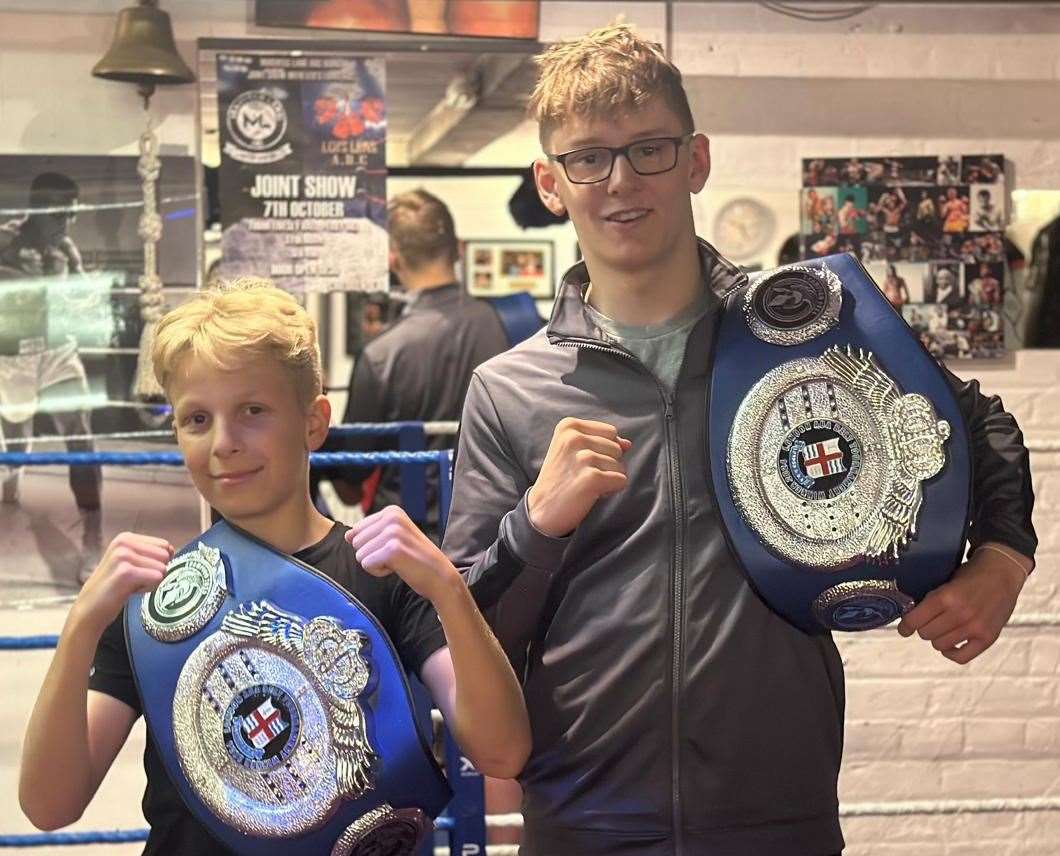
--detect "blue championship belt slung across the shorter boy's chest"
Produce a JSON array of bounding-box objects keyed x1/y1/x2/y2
[{"x1": 125, "y1": 521, "x2": 452, "y2": 856}]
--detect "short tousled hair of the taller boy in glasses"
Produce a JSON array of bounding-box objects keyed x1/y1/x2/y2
[{"x1": 527, "y1": 24, "x2": 695, "y2": 148}]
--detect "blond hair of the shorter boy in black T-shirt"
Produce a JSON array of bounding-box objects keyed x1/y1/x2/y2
[{"x1": 151, "y1": 277, "x2": 323, "y2": 406}]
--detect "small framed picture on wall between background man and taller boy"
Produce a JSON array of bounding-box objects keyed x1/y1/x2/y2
[{"x1": 464, "y1": 240, "x2": 555, "y2": 300}]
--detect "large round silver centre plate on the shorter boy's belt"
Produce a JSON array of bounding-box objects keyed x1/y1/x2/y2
[{"x1": 173, "y1": 601, "x2": 379, "y2": 838}]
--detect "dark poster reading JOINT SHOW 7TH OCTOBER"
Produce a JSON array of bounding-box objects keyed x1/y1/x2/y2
[{"x1": 217, "y1": 52, "x2": 388, "y2": 292}]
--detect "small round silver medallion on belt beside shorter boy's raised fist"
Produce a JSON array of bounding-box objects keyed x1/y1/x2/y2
[{"x1": 140, "y1": 541, "x2": 227, "y2": 642}]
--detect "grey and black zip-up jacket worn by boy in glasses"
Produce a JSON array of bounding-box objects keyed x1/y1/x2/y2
[{"x1": 443, "y1": 244, "x2": 1037, "y2": 856}]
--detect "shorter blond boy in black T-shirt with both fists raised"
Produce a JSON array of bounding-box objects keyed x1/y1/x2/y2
[{"x1": 19, "y1": 280, "x2": 538, "y2": 856}]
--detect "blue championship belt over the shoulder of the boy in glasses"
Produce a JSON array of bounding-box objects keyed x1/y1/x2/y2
[{"x1": 708, "y1": 254, "x2": 971, "y2": 632}]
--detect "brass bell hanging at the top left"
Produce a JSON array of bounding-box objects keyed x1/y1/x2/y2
[{"x1": 92, "y1": 0, "x2": 195, "y2": 107}]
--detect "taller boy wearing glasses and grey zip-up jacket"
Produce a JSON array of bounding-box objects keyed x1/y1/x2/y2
[{"x1": 443, "y1": 25, "x2": 1036, "y2": 856}]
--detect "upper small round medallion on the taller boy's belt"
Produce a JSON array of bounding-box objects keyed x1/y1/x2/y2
[{"x1": 743, "y1": 264, "x2": 843, "y2": 345}]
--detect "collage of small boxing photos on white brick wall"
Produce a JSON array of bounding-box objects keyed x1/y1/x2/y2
[{"x1": 799, "y1": 155, "x2": 1008, "y2": 359}]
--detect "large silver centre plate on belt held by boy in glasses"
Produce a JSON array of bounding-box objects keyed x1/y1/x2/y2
[{"x1": 727, "y1": 347, "x2": 950, "y2": 571}]
